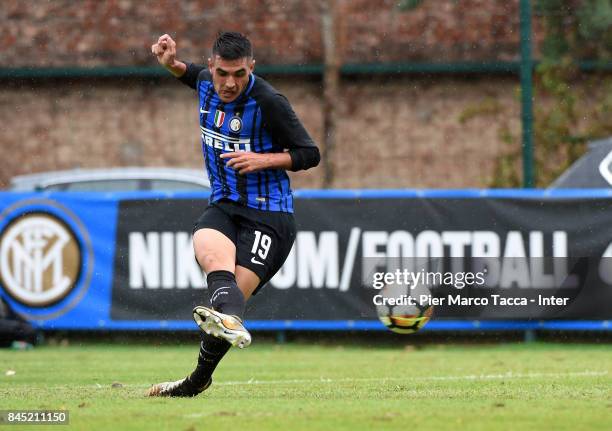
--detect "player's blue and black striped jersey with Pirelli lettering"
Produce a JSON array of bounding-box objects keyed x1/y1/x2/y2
[{"x1": 179, "y1": 64, "x2": 319, "y2": 213}]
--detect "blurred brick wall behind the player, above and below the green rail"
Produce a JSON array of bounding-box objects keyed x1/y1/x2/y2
[{"x1": 0, "y1": 0, "x2": 541, "y2": 187}]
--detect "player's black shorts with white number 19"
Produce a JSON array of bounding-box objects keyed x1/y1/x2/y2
[{"x1": 193, "y1": 200, "x2": 296, "y2": 294}]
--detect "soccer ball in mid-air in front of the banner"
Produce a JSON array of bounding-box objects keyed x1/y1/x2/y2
[{"x1": 376, "y1": 284, "x2": 433, "y2": 334}]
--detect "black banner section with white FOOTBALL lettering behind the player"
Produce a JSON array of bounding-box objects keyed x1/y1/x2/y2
[{"x1": 111, "y1": 197, "x2": 612, "y2": 321}]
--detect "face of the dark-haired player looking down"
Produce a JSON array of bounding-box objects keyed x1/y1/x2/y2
[{"x1": 208, "y1": 55, "x2": 255, "y2": 103}]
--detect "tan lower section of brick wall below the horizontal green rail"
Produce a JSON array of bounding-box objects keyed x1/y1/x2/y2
[{"x1": 0, "y1": 78, "x2": 520, "y2": 188}]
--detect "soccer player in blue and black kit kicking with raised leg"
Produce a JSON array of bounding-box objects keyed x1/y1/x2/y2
[{"x1": 148, "y1": 32, "x2": 320, "y2": 397}]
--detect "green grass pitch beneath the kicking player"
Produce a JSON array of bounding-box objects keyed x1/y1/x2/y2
[{"x1": 0, "y1": 337, "x2": 612, "y2": 431}]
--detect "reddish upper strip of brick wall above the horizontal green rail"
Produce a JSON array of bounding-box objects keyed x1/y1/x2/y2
[{"x1": 0, "y1": 0, "x2": 541, "y2": 67}]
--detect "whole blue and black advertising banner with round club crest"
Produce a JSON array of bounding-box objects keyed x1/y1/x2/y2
[{"x1": 0, "y1": 191, "x2": 612, "y2": 329}]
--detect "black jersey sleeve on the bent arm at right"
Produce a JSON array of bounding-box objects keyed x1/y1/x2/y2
[{"x1": 261, "y1": 93, "x2": 321, "y2": 171}]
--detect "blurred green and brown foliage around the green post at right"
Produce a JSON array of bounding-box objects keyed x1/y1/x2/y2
[{"x1": 491, "y1": 0, "x2": 612, "y2": 187}]
